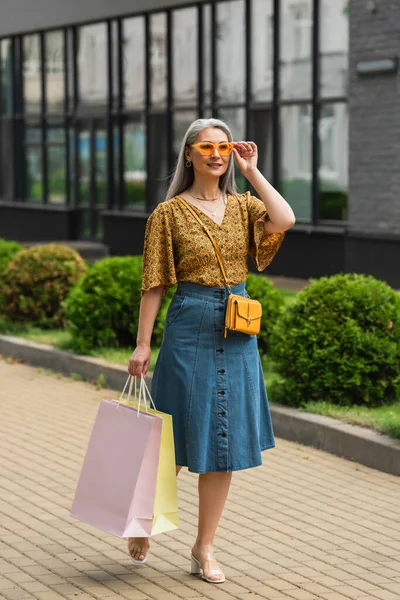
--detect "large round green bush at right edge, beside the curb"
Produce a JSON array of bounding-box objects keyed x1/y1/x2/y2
[{"x1": 271, "y1": 274, "x2": 400, "y2": 406}]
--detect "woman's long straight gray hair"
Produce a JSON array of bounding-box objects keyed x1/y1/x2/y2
[{"x1": 166, "y1": 119, "x2": 237, "y2": 200}]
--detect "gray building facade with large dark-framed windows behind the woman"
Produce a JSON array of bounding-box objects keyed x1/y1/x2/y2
[{"x1": 0, "y1": 0, "x2": 400, "y2": 287}]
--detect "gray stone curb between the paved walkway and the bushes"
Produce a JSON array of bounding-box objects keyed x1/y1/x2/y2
[{"x1": 0, "y1": 335, "x2": 400, "y2": 475}]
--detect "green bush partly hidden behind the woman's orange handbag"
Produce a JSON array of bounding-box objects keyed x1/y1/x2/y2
[{"x1": 246, "y1": 273, "x2": 285, "y2": 354}]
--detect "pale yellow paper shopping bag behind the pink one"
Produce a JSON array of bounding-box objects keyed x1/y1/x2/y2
[{"x1": 130, "y1": 378, "x2": 179, "y2": 536}]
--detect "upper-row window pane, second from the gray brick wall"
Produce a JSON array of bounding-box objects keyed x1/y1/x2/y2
[{"x1": 280, "y1": 0, "x2": 312, "y2": 100}]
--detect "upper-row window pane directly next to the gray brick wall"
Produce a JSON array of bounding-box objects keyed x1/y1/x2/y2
[{"x1": 320, "y1": 0, "x2": 349, "y2": 98}]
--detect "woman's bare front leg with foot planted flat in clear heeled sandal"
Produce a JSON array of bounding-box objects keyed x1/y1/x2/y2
[{"x1": 193, "y1": 472, "x2": 232, "y2": 581}]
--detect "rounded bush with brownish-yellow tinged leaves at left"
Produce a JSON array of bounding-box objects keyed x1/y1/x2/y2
[{"x1": 0, "y1": 244, "x2": 86, "y2": 329}]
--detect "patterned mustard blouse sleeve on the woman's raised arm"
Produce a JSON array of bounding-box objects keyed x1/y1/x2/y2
[{"x1": 247, "y1": 192, "x2": 285, "y2": 271}]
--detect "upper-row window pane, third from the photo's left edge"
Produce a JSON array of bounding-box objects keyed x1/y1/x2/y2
[{"x1": 45, "y1": 31, "x2": 65, "y2": 113}]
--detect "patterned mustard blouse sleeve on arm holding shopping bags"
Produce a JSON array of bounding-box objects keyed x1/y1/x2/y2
[{"x1": 142, "y1": 204, "x2": 177, "y2": 294}]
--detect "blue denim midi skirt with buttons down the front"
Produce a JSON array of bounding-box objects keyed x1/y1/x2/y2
[{"x1": 152, "y1": 282, "x2": 275, "y2": 473}]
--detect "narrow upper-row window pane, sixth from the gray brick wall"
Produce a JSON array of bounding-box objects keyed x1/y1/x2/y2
[{"x1": 150, "y1": 13, "x2": 167, "y2": 106}]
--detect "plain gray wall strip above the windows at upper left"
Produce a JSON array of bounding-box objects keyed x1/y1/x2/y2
[{"x1": 0, "y1": 0, "x2": 206, "y2": 37}]
